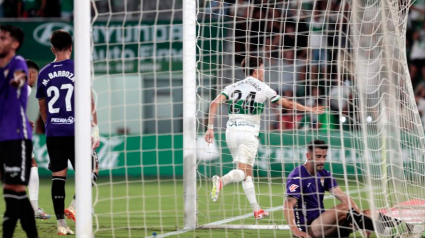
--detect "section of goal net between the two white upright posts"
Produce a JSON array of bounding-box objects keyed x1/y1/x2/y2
[{"x1": 91, "y1": 0, "x2": 184, "y2": 237}]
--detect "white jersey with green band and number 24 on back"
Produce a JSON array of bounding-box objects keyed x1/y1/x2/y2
[{"x1": 221, "y1": 77, "x2": 280, "y2": 133}]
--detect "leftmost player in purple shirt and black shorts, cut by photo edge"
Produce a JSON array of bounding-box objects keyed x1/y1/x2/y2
[{"x1": 0, "y1": 25, "x2": 38, "y2": 237}]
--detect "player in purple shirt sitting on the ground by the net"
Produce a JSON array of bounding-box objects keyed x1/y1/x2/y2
[{"x1": 284, "y1": 140, "x2": 400, "y2": 237}]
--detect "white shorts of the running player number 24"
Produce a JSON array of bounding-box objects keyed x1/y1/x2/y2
[{"x1": 226, "y1": 130, "x2": 258, "y2": 166}]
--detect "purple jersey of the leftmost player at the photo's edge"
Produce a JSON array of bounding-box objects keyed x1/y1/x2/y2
[{"x1": 0, "y1": 55, "x2": 32, "y2": 141}]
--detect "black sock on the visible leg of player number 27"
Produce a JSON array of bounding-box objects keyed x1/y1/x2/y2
[{"x1": 52, "y1": 176, "x2": 66, "y2": 220}]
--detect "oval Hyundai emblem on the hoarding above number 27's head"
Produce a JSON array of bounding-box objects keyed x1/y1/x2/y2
[{"x1": 32, "y1": 22, "x2": 73, "y2": 46}]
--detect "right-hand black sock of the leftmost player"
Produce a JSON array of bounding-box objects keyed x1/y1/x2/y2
[{"x1": 18, "y1": 192, "x2": 38, "y2": 238}]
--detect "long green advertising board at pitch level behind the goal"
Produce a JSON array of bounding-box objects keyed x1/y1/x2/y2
[{"x1": 34, "y1": 131, "x2": 368, "y2": 178}]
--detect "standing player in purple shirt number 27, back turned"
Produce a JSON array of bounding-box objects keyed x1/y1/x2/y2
[{"x1": 36, "y1": 30, "x2": 99, "y2": 235}]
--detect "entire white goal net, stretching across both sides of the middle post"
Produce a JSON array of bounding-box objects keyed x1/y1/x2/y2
[{"x1": 88, "y1": 0, "x2": 425, "y2": 237}]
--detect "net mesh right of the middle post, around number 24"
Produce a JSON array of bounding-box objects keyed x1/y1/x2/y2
[{"x1": 198, "y1": 0, "x2": 425, "y2": 235}]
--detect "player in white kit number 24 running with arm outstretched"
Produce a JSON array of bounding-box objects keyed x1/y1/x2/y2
[{"x1": 205, "y1": 56, "x2": 325, "y2": 219}]
